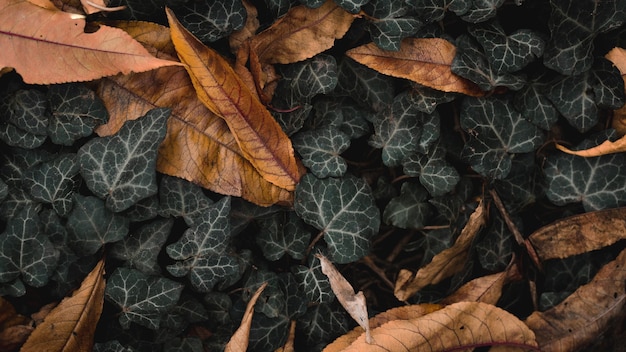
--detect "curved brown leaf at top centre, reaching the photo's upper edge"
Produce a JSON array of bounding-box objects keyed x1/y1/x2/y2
[{"x1": 251, "y1": 0, "x2": 354, "y2": 64}]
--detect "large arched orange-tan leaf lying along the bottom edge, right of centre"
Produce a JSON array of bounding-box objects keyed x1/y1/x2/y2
[{"x1": 342, "y1": 302, "x2": 539, "y2": 352}]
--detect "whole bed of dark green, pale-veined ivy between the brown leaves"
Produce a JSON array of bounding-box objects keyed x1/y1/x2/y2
[{"x1": 0, "y1": 0, "x2": 626, "y2": 351}]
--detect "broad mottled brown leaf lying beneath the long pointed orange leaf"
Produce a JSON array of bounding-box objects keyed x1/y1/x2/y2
[{"x1": 97, "y1": 22, "x2": 292, "y2": 206}]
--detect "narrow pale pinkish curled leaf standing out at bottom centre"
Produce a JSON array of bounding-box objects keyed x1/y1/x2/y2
[{"x1": 315, "y1": 253, "x2": 373, "y2": 343}]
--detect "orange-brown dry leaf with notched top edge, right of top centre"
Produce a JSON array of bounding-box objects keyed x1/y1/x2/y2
[{"x1": 346, "y1": 38, "x2": 485, "y2": 96}]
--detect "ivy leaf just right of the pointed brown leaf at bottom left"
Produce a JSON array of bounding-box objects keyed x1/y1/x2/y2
[{"x1": 104, "y1": 267, "x2": 183, "y2": 330}]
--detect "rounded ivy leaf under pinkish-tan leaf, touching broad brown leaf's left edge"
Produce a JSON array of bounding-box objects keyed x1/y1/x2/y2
[{"x1": 48, "y1": 83, "x2": 109, "y2": 146}]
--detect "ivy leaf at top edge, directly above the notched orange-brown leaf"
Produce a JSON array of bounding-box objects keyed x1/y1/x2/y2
[{"x1": 365, "y1": 0, "x2": 422, "y2": 51}]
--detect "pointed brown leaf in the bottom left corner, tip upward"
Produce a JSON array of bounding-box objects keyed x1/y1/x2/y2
[{"x1": 20, "y1": 260, "x2": 105, "y2": 352}]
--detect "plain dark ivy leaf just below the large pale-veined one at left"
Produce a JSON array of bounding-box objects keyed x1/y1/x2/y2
[{"x1": 67, "y1": 194, "x2": 129, "y2": 256}]
